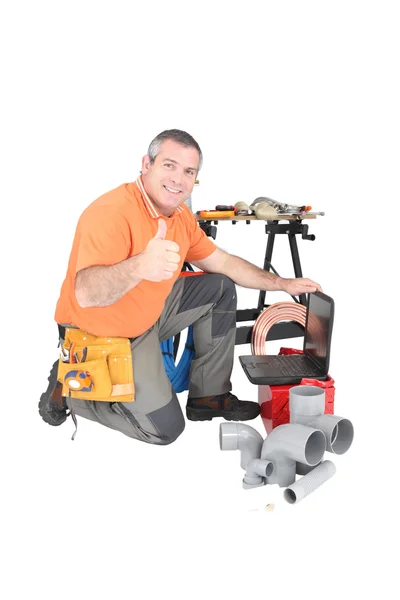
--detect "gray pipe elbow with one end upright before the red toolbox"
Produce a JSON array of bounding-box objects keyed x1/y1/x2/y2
[{"x1": 289, "y1": 385, "x2": 354, "y2": 454}]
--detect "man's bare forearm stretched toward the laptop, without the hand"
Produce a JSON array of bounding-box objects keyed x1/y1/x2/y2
[{"x1": 222, "y1": 254, "x2": 283, "y2": 291}]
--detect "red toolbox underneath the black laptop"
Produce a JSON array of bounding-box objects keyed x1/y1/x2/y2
[{"x1": 258, "y1": 348, "x2": 335, "y2": 433}]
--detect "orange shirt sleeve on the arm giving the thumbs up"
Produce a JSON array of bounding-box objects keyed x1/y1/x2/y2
[{"x1": 75, "y1": 206, "x2": 132, "y2": 273}]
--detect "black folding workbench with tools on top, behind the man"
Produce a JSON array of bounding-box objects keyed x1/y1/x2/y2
[{"x1": 196, "y1": 214, "x2": 316, "y2": 345}]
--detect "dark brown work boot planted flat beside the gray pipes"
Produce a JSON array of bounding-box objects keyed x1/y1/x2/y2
[{"x1": 186, "y1": 392, "x2": 260, "y2": 421}]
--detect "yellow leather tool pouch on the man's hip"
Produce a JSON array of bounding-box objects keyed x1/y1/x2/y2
[{"x1": 57, "y1": 327, "x2": 135, "y2": 402}]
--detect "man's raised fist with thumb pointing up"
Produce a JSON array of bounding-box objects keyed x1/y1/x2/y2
[{"x1": 139, "y1": 218, "x2": 181, "y2": 281}]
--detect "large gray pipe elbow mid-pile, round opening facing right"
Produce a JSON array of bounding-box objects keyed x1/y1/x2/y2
[{"x1": 261, "y1": 423, "x2": 326, "y2": 487}]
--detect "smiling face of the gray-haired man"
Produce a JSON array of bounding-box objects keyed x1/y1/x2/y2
[{"x1": 142, "y1": 140, "x2": 200, "y2": 217}]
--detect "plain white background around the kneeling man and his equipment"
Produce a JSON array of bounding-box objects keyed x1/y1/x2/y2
[{"x1": 0, "y1": 0, "x2": 400, "y2": 600}]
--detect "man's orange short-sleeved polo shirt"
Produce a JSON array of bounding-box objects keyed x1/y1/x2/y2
[{"x1": 55, "y1": 177, "x2": 216, "y2": 337}]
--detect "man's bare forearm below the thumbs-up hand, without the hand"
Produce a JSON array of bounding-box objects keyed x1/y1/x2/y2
[{"x1": 75, "y1": 254, "x2": 142, "y2": 308}]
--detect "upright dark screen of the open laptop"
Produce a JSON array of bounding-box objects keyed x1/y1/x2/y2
[{"x1": 304, "y1": 292, "x2": 334, "y2": 373}]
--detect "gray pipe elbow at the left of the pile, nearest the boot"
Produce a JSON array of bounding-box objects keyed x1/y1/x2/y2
[{"x1": 219, "y1": 423, "x2": 264, "y2": 469}]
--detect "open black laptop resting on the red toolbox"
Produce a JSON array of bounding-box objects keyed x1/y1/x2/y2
[{"x1": 239, "y1": 292, "x2": 335, "y2": 385}]
